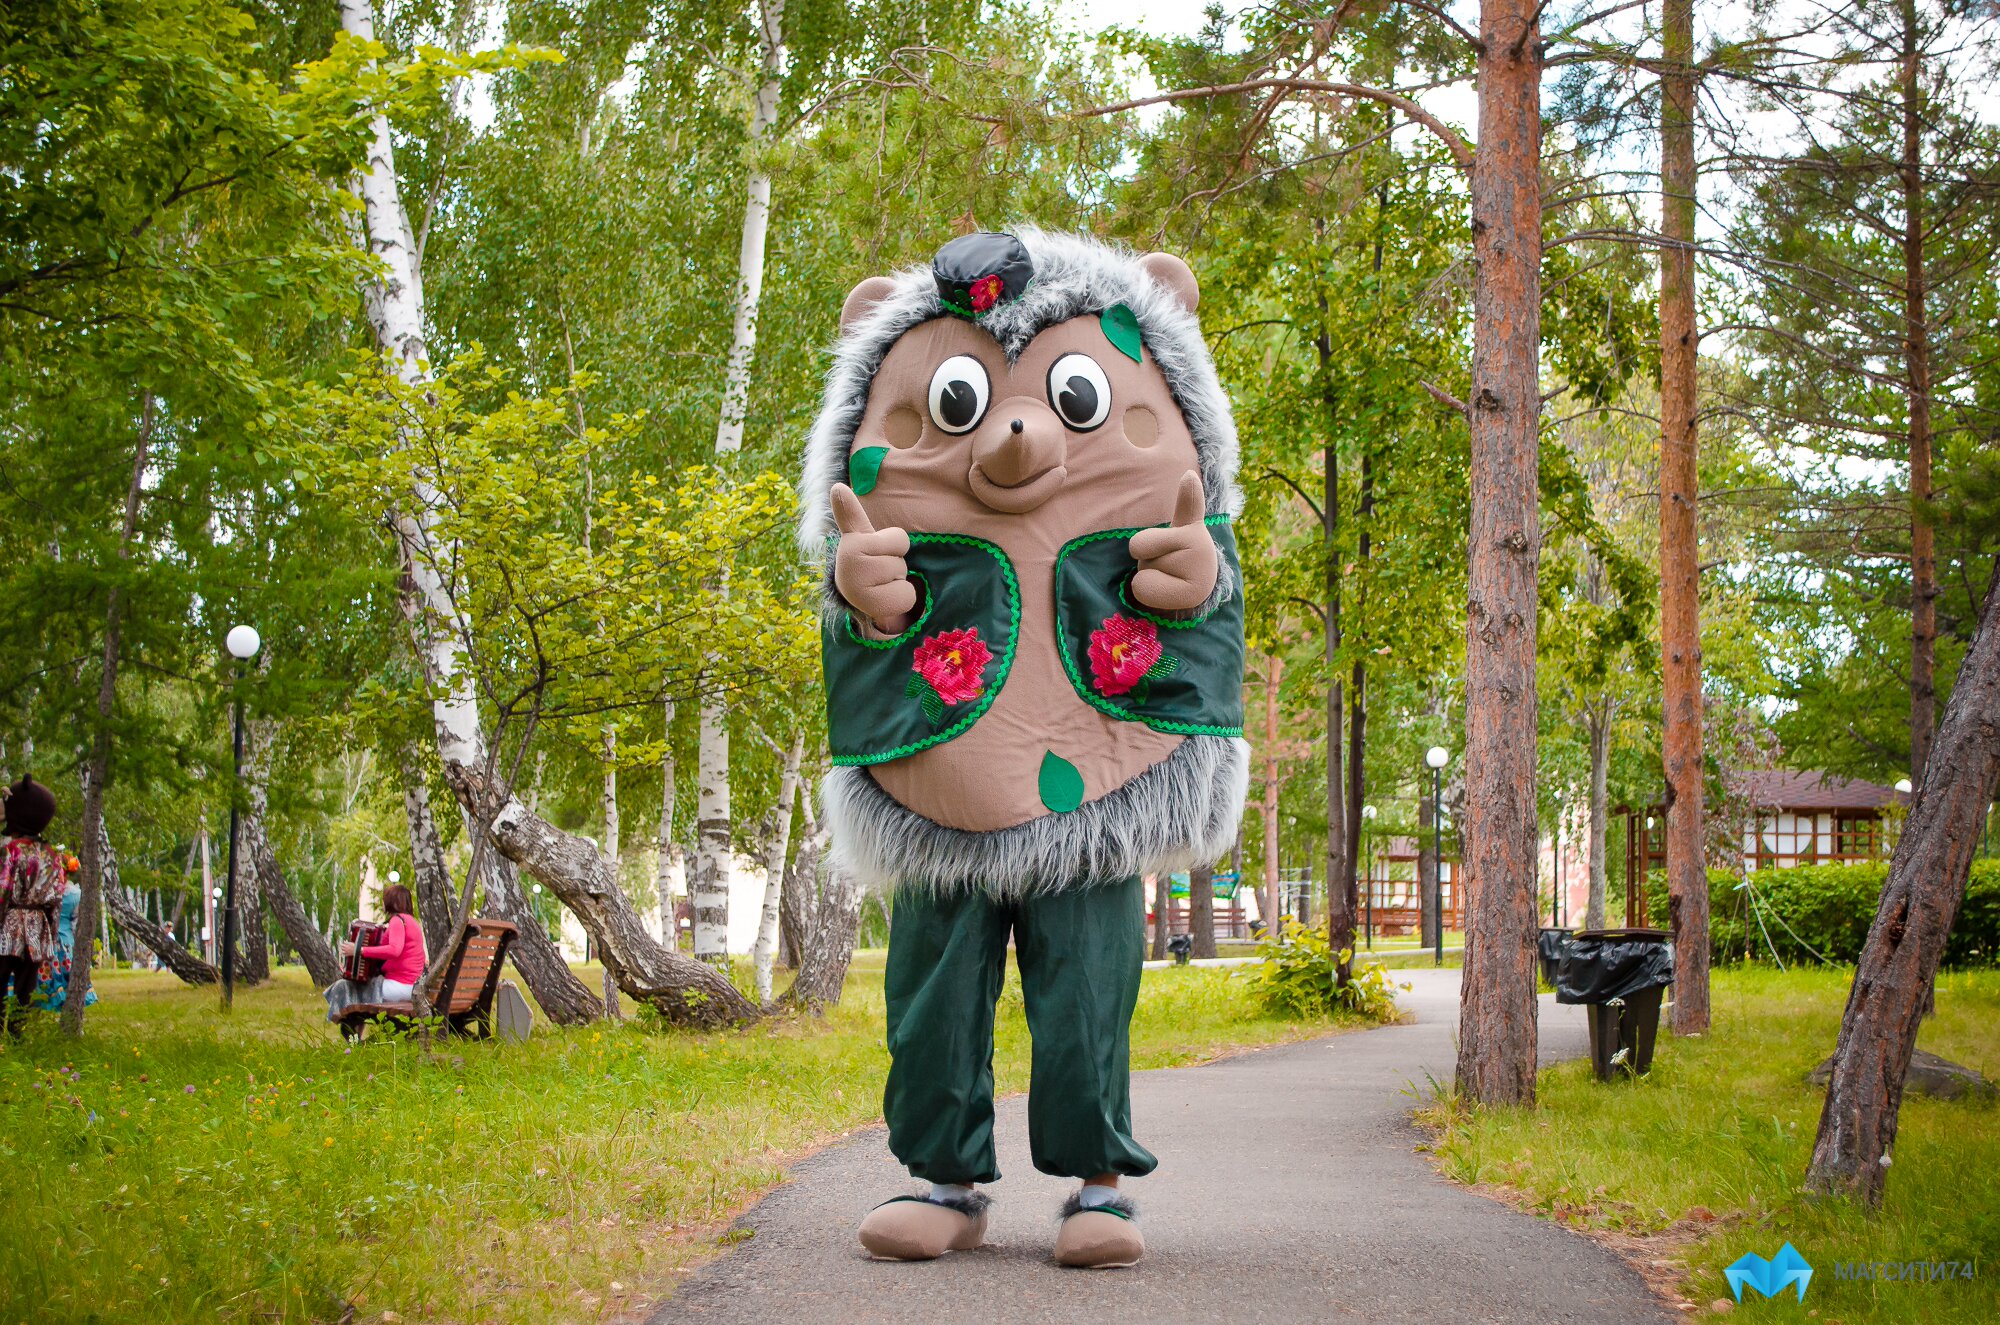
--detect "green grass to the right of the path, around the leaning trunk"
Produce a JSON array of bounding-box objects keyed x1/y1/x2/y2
[{"x1": 1424, "y1": 967, "x2": 2000, "y2": 1325}]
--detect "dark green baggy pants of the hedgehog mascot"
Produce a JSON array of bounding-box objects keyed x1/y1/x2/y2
[{"x1": 882, "y1": 877, "x2": 1158, "y2": 1183}]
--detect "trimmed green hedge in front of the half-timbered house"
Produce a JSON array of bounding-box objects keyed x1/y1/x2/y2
[{"x1": 1646, "y1": 861, "x2": 2000, "y2": 967}]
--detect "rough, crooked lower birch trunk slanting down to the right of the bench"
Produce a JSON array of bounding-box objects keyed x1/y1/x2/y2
[{"x1": 444, "y1": 765, "x2": 758, "y2": 1027}]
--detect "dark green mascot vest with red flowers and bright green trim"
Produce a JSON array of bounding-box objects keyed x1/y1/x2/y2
[{"x1": 820, "y1": 514, "x2": 1244, "y2": 765}]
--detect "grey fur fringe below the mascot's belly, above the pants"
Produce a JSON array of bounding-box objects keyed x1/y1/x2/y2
[{"x1": 820, "y1": 737, "x2": 1250, "y2": 897}]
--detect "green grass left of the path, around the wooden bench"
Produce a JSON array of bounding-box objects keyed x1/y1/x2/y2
[{"x1": 0, "y1": 953, "x2": 1330, "y2": 1325}]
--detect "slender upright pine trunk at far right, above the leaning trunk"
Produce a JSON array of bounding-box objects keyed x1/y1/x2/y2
[{"x1": 1904, "y1": 0, "x2": 1938, "y2": 788}]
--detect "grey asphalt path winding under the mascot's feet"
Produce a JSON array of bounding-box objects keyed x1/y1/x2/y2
[{"x1": 650, "y1": 969, "x2": 1678, "y2": 1325}]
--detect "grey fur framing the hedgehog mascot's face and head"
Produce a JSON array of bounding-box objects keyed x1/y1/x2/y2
[{"x1": 798, "y1": 226, "x2": 1242, "y2": 558}]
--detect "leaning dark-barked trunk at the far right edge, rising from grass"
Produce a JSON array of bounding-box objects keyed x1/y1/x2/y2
[{"x1": 1806, "y1": 564, "x2": 2000, "y2": 1205}]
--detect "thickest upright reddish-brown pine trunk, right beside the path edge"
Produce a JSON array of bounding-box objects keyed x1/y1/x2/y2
[{"x1": 1458, "y1": 0, "x2": 1542, "y2": 1105}]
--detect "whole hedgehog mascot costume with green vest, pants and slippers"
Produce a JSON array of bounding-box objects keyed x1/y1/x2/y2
[{"x1": 800, "y1": 230, "x2": 1248, "y2": 1267}]
